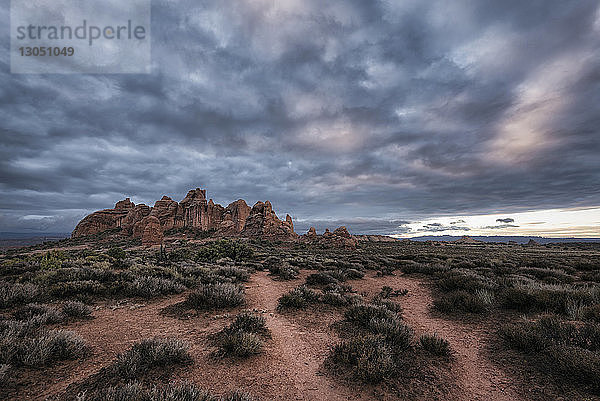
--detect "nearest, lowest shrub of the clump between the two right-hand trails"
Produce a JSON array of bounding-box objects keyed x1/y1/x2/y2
[{"x1": 331, "y1": 336, "x2": 396, "y2": 383}]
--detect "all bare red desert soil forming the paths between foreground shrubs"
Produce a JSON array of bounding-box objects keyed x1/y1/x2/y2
[{"x1": 9, "y1": 272, "x2": 519, "y2": 400}]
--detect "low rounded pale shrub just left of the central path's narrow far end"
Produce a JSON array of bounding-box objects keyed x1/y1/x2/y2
[{"x1": 187, "y1": 283, "x2": 244, "y2": 309}]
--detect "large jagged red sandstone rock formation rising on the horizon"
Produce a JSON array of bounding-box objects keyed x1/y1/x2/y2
[{"x1": 72, "y1": 188, "x2": 298, "y2": 244}]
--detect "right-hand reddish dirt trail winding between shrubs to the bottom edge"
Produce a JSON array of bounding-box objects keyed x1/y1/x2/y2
[{"x1": 353, "y1": 273, "x2": 521, "y2": 401}]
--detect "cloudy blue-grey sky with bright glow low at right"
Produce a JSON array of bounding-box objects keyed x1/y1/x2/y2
[{"x1": 0, "y1": 0, "x2": 600, "y2": 237}]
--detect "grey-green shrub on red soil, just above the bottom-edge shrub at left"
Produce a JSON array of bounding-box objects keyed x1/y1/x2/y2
[{"x1": 111, "y1": 338, "x2": 192, "y2": 379}]
